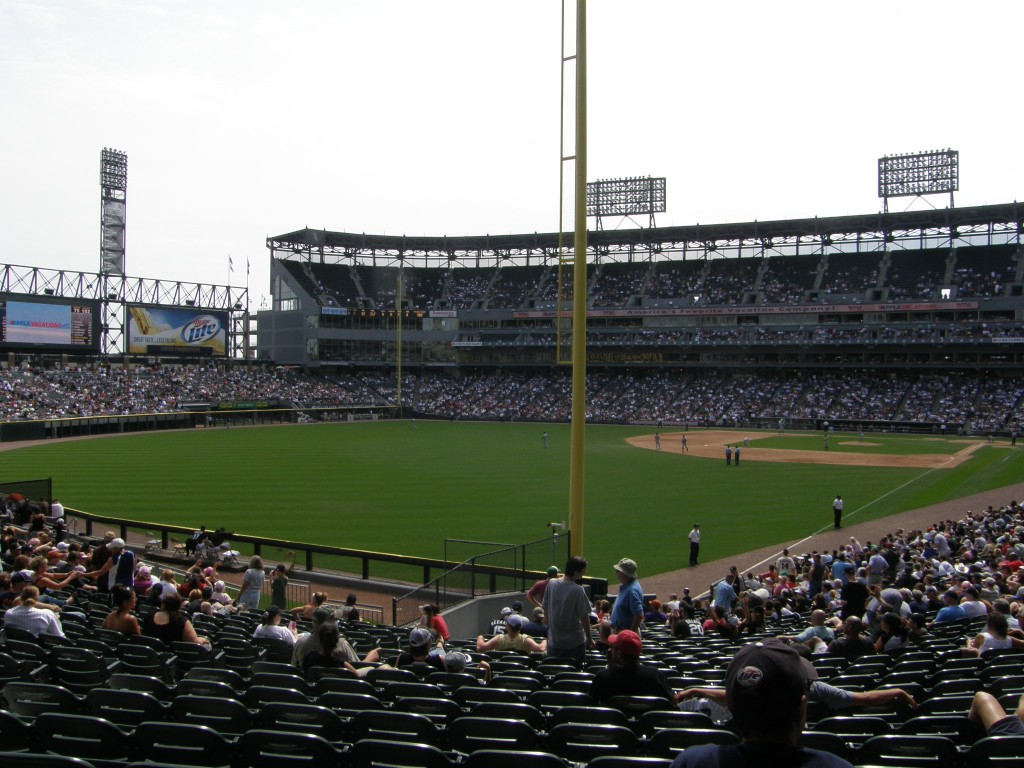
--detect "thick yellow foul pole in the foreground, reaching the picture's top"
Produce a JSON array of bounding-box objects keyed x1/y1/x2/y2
[{"x1": 568, "y1": 0, "x2": 587, "y2": 556}]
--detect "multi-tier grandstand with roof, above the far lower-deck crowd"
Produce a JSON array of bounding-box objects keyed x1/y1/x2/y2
[{"x1": 257, "y1": 203, "x2": 1024, "y2": 375}]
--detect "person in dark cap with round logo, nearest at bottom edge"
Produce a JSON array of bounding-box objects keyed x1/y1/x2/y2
[{"x1": 672, "y1": 639, "x2": 850, "y2": 768}]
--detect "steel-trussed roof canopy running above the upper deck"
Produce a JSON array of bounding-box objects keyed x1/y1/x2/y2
[{"x1": 266, "y1": 202, "x2": 1024, "y2": 266}]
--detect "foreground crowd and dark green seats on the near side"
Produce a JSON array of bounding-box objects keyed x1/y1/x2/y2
[{"x1": 6, "y1": 489, "x2": 1024, "y2": 768}]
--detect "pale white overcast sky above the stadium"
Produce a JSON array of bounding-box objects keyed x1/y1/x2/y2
[{"x1": 0, "y1": 0, "x2": 1024, "y2": 306}]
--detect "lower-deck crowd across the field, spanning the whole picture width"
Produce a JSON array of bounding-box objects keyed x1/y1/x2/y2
[{"x1": 6, "y1": 367, "x2": 1024, "y2": 434}]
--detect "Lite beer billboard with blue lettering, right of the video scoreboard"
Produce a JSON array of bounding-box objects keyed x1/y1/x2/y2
[{"x1": 125, "y1": 304, "x2": 228, "y2": 357}]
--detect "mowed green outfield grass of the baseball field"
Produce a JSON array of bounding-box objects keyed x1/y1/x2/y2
[{"x1": 0, "y1": 420, "x2": 1024, "y2": 574}]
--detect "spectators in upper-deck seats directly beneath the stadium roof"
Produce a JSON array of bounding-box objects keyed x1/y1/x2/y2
[{"x1": 293, "y1": 244, "x2": 1017, "y2": 309}]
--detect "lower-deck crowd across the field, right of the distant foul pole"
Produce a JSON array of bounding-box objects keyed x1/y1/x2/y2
[{"x1": 410, "y1": 371, "x2": 1024, "y2": 433}]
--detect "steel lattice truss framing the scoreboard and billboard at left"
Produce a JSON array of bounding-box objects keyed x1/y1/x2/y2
[{"x1": 0, "y1": 264, "x2": 249, "y2": 357}]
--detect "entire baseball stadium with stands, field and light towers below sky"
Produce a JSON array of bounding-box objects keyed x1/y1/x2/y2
[{"x1": 6, "y1": 6, "x2": 1024, "y2": 768}]
